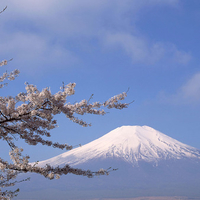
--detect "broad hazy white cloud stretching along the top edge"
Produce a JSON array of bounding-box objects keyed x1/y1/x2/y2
[{"x1": 8, "y1": 0, "x2": 179, "y2": 36}]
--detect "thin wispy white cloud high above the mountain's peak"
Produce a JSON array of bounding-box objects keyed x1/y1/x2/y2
[{"x1": 102, "y1": 33, "x2": 191, "y2": 65}]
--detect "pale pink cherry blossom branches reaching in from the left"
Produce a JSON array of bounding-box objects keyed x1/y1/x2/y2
[{"x1": 0, "y1": 60, "x2": 129, "y2": 199}]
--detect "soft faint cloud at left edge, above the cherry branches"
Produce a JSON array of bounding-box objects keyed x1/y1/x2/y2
[{"x1": 0, "y1": 33, "x2": 77, "y2": 73}]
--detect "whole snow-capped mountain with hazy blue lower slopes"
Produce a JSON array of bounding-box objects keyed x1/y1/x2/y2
[{"x1": 16, "y1": 126, "x2": 200, "y2": 200}]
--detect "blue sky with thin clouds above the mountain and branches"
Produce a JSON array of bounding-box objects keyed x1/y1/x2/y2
[{"x1": 0, "y1": 0, "x2": 200, "y2": 161}]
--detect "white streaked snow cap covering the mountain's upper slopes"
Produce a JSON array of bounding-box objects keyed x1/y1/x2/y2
[{"x1": 39, "y1": 126, "x2": 200, "y2": 166}]
